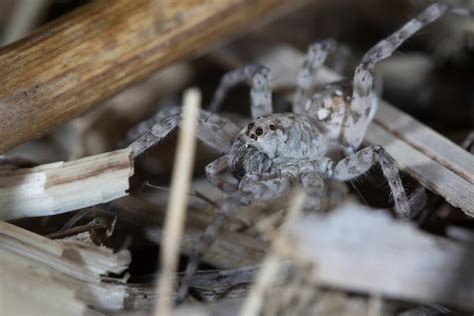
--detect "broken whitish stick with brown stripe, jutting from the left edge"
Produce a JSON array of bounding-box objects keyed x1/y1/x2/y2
[{"x1": 0, "y1": 148, "x2": 133, "y2": 220}]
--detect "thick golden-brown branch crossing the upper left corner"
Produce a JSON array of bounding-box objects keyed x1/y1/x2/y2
[{"x1": 0, "y1": 0, "x2": 304, "y2": 153}]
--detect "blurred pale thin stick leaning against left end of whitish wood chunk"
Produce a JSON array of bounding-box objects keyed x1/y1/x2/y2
[{"x1": 240, "y1": 191, "x2": 306, "y2": 316}]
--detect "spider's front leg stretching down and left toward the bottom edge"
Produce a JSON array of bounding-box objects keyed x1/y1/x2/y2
[{"x1": 176, "y1": 175, "x2": 292, "y2": 303}]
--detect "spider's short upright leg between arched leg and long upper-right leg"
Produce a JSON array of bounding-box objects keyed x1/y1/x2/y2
[{"x1": 293, "y1": 40, "x2": 336, "y2": 114}]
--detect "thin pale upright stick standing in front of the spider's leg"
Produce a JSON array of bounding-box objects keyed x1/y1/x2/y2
[{"x1": 155, "y1": 88, "x2": 201, "y2": 315}]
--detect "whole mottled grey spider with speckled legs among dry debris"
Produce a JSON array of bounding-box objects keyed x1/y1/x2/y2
[{"x1": 130, "y1": 3, "x2": 472, "y2": 301}]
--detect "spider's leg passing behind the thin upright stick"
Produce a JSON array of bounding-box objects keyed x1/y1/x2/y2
[{"x1": 130, "y1": 110, "x2": 240, "y2": 158}]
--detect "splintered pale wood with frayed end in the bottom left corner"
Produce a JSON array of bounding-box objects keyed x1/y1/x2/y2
[{"x1": 0, "y1": 221, "x2": 131, "y2": 315}]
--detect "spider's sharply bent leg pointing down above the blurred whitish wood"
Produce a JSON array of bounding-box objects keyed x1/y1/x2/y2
[{"x1": 332, "y1": 146, "x2": 411, "y2": 219}]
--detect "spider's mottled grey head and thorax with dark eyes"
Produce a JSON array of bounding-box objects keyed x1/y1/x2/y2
[{"x1": 228, "y1": 113, "x2": 328, "y2": 179}]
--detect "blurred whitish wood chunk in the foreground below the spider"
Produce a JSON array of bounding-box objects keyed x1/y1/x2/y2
[{"x1": 283, "y1": 204, "x2": 474, "y2": 311}]
